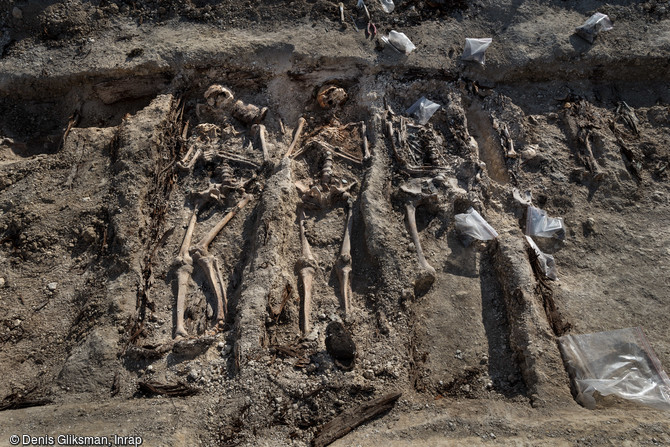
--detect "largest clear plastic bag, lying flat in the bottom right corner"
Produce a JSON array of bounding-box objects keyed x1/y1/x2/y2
[{"x1": 558, "y1": 327, "x2": 670, "y2": 410}]
